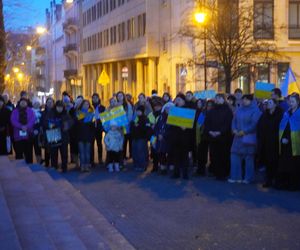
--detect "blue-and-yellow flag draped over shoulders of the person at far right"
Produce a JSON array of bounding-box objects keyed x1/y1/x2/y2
[{"x1": 279, "y1": 108, "x2": 300, "y2": 156}]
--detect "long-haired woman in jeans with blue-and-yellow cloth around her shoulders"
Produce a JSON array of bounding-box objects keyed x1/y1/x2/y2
[{"x1": 76, "y1": 100, "x2": 95, "y2": 172}]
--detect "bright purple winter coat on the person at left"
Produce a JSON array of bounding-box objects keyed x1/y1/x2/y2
[{"x1": 10, "y1": 107, "x2": 35, "y2": 141}]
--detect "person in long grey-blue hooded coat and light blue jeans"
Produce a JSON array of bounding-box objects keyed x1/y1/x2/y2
[{"x1": 228, "y1": 95, "x2": 261, "y2": 184}]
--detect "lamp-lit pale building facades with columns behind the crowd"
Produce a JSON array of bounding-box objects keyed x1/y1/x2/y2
[{"x1": 41, "y1": 0, "x2": 300, "y2": 101}]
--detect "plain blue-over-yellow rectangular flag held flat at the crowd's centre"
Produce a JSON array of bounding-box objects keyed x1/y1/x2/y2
[{"x1": 167, "y1": 107, "x2": 196, "y2": 128}]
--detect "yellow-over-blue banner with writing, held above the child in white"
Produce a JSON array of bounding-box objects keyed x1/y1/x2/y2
[{"x1": 100, "y1": 106, "x2": 129, "y2": 131}]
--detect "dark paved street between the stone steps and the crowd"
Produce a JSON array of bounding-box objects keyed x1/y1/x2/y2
[{"x1": 65, "y1": 168, "x2": 300, "y2": 249}]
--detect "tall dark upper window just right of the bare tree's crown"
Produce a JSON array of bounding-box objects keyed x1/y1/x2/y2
[{"x1": 254, "y1": 0, "x2": 274, "y2": 39}]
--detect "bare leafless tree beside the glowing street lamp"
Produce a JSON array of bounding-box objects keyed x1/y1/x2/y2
[{"x1": 180, "y1": 0, "x2": 277, "y2": 93}]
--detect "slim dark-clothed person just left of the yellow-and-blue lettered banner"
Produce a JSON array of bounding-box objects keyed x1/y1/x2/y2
[{"x1": 91, "y1": 93, "x2": 105, "y2": 167}]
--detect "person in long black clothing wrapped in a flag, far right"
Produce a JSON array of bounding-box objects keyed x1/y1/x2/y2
[{"x1": 276, "y1": 94, "x2": 300, "y2": 191}]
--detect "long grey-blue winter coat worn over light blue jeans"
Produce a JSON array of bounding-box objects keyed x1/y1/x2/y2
[{"x1": 231, "y1": 101, "x2": 261, "y2": 155}]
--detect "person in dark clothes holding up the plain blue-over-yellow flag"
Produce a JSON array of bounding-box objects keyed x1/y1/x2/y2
[{"x1": 167, "y1": 93, "x2": 190, "y2": 179}]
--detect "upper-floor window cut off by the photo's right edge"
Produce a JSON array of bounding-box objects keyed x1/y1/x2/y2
[{"x1": 289, "y1": 0, "x2": 300, "y2": 39}]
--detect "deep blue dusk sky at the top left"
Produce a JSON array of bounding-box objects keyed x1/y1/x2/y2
[{"x1": 4, "y1": 0, "x2": 49, "y2": 31}]
